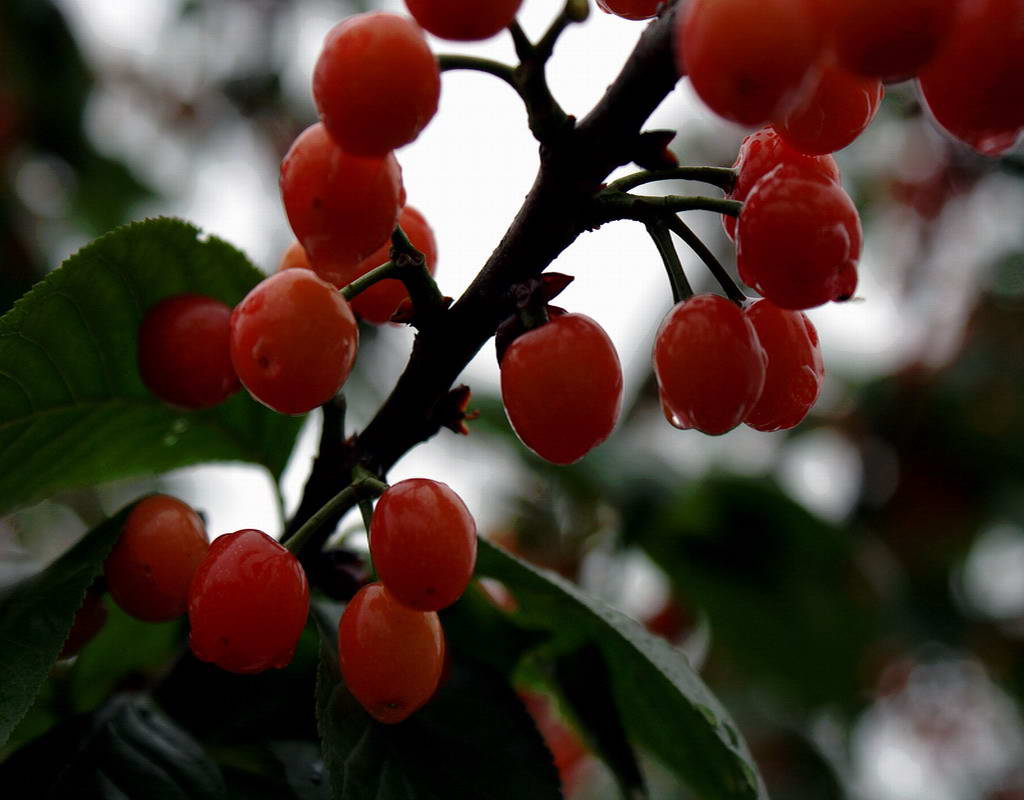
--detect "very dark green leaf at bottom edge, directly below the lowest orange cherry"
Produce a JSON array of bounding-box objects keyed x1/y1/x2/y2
[{"x1": 316, "y1": 645, "x2": 562, "y2": 800}]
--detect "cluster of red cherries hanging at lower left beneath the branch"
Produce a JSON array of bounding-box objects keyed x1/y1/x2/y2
[{"x1": 70, "y1": 478, "x2": 476, "y2": 723}]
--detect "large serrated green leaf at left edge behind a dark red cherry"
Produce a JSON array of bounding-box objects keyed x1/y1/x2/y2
[{"x1": 0, "y1": 218, "x2": 301, "y2": 513}]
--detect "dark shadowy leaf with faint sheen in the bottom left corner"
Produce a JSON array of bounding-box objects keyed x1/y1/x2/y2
[{"x1": 0, "y1": 694, "x2": 225, "y2": 800}]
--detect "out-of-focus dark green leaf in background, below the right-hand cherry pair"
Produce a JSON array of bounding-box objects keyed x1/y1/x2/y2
[{"x1": 624, "y1": 475, "x2": 874, "y2": 708}]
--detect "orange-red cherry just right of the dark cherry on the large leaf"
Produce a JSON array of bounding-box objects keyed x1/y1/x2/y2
[{"x1": 231, "y1": 269, "x2": 359, "y2": 414}]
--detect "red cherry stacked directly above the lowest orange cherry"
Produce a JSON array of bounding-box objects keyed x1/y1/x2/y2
[{"x1": 370, "y1": 478, "x2": 476, "y2": 612}]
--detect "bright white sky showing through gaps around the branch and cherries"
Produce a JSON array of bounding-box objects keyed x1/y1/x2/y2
[{"x1": 32, "y1": 0, "x2": 1024, "y2": 800}]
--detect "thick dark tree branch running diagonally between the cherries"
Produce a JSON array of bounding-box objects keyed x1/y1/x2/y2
[{"x1": 289, "y1": 4, "x2": 680, "y2": 557}]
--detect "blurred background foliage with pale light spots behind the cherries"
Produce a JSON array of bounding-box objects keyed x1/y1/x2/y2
[{"x1": 0, "y1": 0, "x2": 1024, "y2": 800}]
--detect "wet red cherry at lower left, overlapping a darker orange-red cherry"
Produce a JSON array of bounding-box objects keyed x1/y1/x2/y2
[{"x1": 188, "y1": 530, "x2": 309, "y2": 674}]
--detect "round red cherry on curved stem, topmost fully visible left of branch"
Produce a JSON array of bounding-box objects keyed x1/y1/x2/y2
[{"x1": 313, "y1": 11, "x2": 441, "y2": 157}]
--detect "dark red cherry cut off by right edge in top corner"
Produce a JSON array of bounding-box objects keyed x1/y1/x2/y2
[{"x1": 920, "y1": 0, "x2": 1024, "y2": 157}]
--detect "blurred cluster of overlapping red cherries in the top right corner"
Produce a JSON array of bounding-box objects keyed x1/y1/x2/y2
[{"x1": 675, "y1": 0, "x2": 1024, "y2": 156}]
